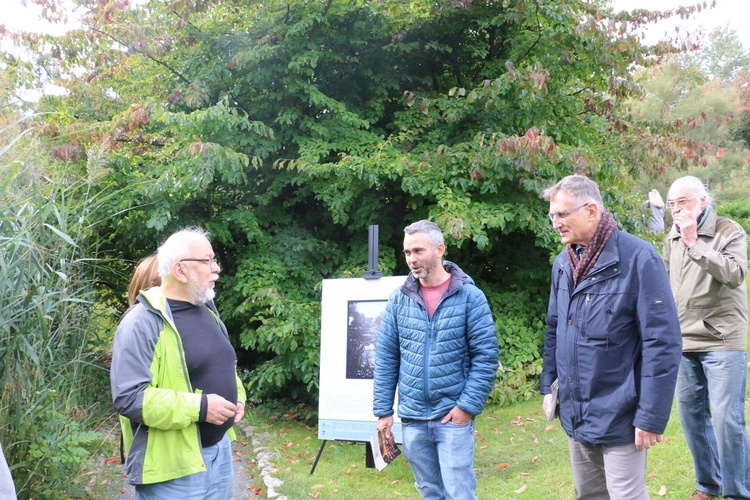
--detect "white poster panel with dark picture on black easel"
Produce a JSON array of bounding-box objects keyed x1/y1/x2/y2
[{"x1": 318, "y1": 276, "x2": 406, "y2": 443}]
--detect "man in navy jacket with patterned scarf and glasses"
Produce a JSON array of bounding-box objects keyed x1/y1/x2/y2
[{"x1": 541, "y1": 175, "x2": 682, "y2": 500}]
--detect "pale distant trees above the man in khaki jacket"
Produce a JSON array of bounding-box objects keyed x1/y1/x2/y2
[{"x1": 632, "y1": 26, "x2": 750, "y2": 205}]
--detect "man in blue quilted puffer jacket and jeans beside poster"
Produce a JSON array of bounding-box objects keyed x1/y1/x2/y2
[{"x1": 373, "y1": 220, "x2": 498, "y2": 499}]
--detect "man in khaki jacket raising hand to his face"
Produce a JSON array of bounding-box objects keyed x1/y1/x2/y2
[{"x1": 664, "y1": 176, "x2": 750, "y2": 500}]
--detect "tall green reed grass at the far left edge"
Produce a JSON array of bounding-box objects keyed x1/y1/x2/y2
[{"x1": 0, "y1": 116, "x2": 114, "y2": 499}]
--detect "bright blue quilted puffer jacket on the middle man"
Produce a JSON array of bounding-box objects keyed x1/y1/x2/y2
[{"x1": 373, "y1": 261, "x2": 499, "y2": 420}]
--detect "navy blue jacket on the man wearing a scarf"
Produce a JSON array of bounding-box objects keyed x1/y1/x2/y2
[{"x1": 541, "y1": 231, "x2": 682, "y2": 445}]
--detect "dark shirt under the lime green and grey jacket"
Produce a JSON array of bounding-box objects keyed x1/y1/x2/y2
[{"x1": 168, "y1": 299, "x2": 237, "y2": 447}]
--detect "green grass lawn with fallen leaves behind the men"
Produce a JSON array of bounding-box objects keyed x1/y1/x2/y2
[{"x1": 246, "y1": 397, "x2": 732, "y2": 500}]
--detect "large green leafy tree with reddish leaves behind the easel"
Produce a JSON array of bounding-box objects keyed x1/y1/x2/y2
[{"x1": 2, "y1": 0, "x2": 720, "y2": 408}]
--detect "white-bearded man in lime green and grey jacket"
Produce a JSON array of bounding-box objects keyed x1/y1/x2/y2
[{"x1": 110, "y1": 228, "x2": 245, "y2": 500}]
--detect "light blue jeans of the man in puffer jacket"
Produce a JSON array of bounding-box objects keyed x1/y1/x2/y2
[{"x1": 401, "y1": 419, "x2": 477, "y2": 500}]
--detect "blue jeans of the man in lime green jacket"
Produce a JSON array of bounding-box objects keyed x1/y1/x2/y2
[{"x1": 135, "y1": 435, "x2": 234, "y2": 500}]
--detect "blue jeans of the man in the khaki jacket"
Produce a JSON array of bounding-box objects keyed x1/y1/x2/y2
[{"x1": 676, "y1": 351, "x2": 750, "y2": 499}]
